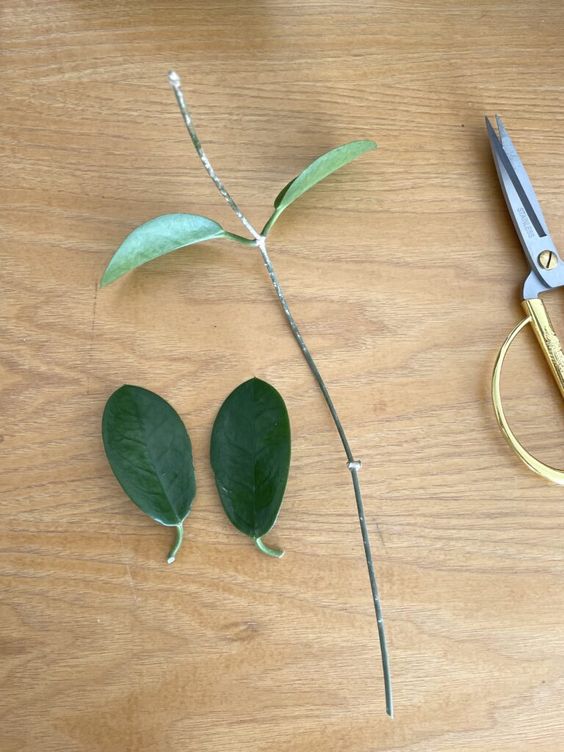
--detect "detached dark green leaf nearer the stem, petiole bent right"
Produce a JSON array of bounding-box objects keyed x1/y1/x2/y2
[{"x1": 211, "y1": 379, "x2": 290, "y2": 557}]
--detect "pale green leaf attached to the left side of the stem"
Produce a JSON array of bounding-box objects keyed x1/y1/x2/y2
[{"x1": 100, "y1": 214, "x2": 228, "y2": 287}]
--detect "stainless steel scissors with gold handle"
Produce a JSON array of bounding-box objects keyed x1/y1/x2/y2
[{"x1": 486, "y1": 115, "x2": 564, "y2": 485}]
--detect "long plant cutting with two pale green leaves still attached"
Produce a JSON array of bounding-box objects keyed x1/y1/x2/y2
[{"x1": 101, "y1": 71, "x2": 393, "y2": 717}]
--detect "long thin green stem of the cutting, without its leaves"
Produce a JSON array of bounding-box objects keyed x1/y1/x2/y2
[{"x1": 169, "y1": 71, "x2": 394, "y2": 718}]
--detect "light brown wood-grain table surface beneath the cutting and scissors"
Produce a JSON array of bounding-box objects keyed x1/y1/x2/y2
[{"x1": 0, "y1": 0, "x2": 564, "y2": 752}]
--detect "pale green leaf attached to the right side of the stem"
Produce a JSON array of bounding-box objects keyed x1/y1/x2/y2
[{"x1": 262, "y1": 140, "x2": 376, "y2": 235}]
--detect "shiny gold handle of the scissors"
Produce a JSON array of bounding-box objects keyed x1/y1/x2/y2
[{"x1": 492, "y1": 298, "x2": 564, "y2": 486}]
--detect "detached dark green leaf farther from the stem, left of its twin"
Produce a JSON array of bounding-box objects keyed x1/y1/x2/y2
[{"x1": 102, "y1": 385, "x2": 196, "y2": 564}]
